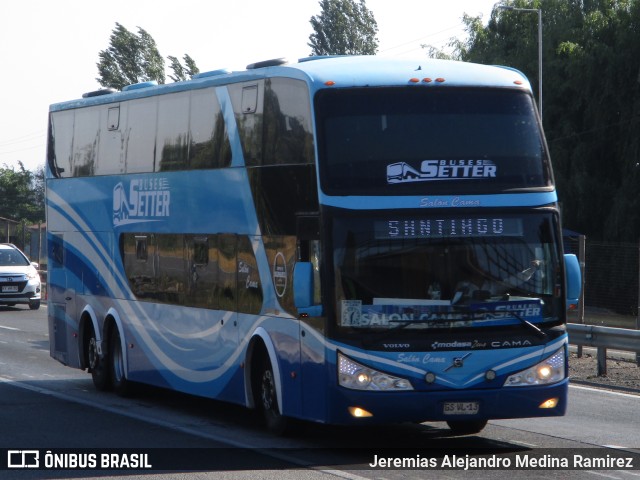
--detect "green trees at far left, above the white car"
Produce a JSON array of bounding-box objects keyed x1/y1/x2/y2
[{"x1": 0, "y1": 162, "x2": 44, "y2": 223}]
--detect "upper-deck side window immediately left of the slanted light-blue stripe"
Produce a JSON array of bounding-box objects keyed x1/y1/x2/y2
[{"x1": 189, "y1": 88, "x2": 231, "y2": 169}]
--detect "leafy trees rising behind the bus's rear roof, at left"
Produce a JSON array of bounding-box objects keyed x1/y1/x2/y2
[{"x1": 96, "y1": 23, "x2": 200, "y2": 90}]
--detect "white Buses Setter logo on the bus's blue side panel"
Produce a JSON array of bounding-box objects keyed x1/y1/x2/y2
[{"x1": 113, "y1": 178, "x2": 171, "y2": 226}]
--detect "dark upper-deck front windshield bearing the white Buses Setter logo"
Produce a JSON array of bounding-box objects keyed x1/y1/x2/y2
[{"x1": 315, "y1": 87, "x2": 552, "y2": 195}]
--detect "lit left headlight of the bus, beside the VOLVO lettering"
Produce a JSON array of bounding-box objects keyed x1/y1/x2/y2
[{"x1": 338, "y1": 352, "x2": 413, "y2": 392}]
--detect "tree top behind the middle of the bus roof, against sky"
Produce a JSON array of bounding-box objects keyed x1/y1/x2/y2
[{"x1": 308, "y1": 0, "x2": 378, "y2": 56}]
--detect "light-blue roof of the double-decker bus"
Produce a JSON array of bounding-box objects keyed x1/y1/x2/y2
[{"x1": 50, "y1": 56, "x2": 531, "y2": 112}]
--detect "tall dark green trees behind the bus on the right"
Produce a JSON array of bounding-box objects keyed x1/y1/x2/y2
[{"x1": 456, "y1": 0, "x2": 640, "y2": 241}]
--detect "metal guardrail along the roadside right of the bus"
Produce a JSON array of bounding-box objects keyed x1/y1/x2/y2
[{"x1": 567, "y1": 323, "x2": 640, "y2": 376}]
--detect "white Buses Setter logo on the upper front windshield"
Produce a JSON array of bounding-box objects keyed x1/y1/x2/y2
[{"x1": 387, "y1": 160, "x2": 498, "y2": 183}]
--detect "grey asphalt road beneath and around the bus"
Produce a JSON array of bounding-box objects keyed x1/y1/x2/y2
[{"x1": 0, "y1": 307, "x2": 640, "y2": 480}]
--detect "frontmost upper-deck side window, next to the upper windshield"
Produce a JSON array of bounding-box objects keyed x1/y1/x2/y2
[{"x1": 262, "y1": 78, "x2": 313, "y2": 165}]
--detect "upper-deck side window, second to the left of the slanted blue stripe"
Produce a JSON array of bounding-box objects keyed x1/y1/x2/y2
[{"x1": 156, "y1": 92, "x2": 189, "y2": 171}]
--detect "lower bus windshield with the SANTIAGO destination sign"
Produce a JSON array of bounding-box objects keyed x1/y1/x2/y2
[{"x1": 333, "y1": 212, "x2": 563, "y2": 329}]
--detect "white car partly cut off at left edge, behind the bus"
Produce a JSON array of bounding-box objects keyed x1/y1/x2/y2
[{"x1": 0, "y1": 243, "x2": 41, "y2": 310}]
